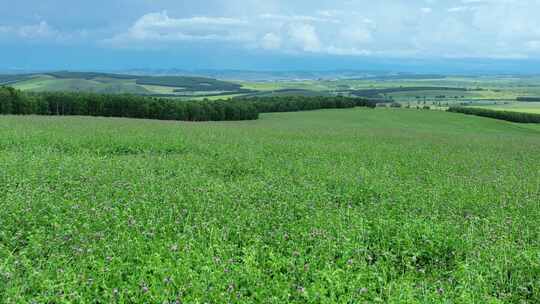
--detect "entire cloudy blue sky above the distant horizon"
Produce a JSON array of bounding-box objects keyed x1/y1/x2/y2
[{"x1": 0, "y1": 0, "x2": 540, "y2": 73}]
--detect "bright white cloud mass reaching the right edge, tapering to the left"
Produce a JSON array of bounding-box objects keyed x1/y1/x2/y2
[{"x1": 99, "y1": 0, "x2": 540, "y2": 58}]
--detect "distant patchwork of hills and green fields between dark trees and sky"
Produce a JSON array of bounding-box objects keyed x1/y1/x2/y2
[{"x1": 6, "y1": 72, "x2": 540, "y2": 105}]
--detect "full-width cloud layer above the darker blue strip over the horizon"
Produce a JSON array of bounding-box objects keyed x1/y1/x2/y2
[{"x1": 0, "y1": 0, "x2": 540, "y2": 58}]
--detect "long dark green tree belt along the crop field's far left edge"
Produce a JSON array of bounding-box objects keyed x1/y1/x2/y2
[{"x1": 0, "y1": 87, "x2": 375, "y2": 121}]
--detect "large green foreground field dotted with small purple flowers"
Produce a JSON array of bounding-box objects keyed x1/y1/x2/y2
[{"x1": 0, "y1": 109, "x2": 540, "y2": 303}]
